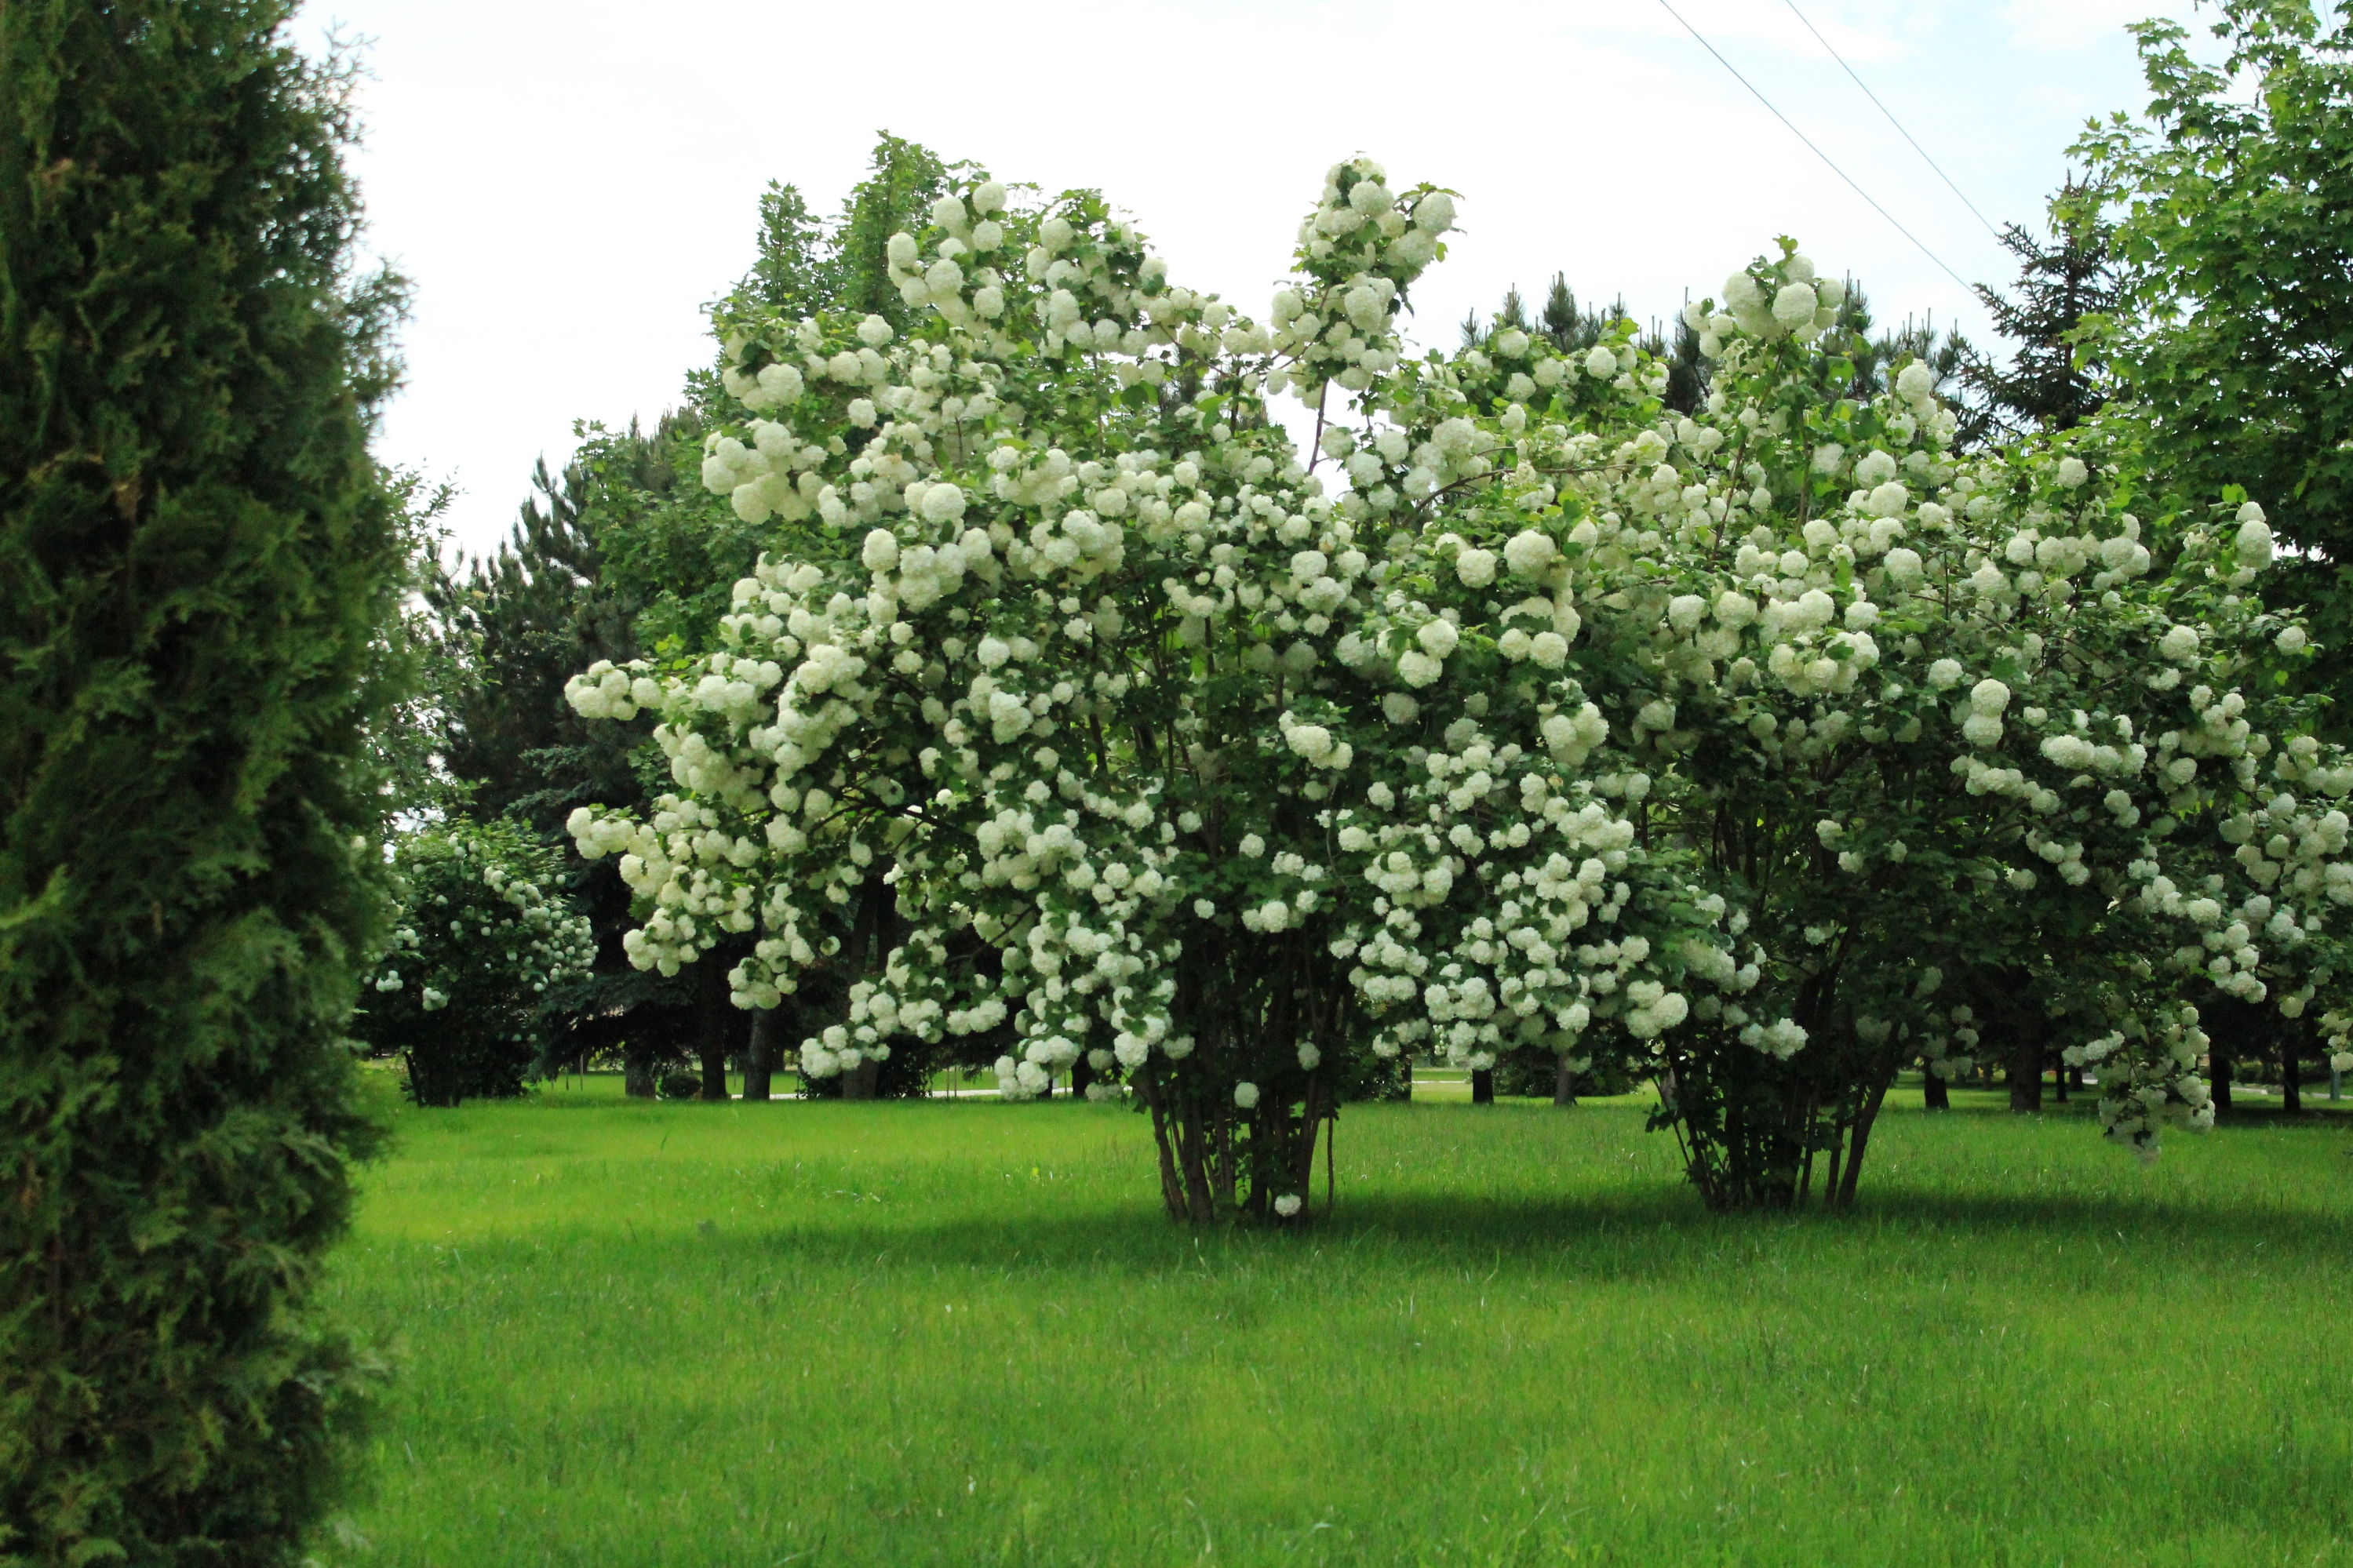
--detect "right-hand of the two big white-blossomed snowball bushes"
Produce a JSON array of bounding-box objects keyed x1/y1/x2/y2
[{"x1": 1492, "y1": 242, "x2": 2353, "y2": 1201}]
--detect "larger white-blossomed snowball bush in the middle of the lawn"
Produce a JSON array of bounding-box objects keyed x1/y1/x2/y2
[{"x1": 574, "y1": 162, "x2": 1736, "y2": 1220}]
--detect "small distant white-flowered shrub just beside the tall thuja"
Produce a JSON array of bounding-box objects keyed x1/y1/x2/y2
[{"x1": 353, "y1": 823, "x2": 596, "y2": 1105}]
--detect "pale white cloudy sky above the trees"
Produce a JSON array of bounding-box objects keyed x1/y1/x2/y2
[{"x1": 304, "y1": 0, "x2": 2188, "y2": 562}]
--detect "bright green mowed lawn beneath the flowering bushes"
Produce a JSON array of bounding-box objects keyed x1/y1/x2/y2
[{"x1": 322, "y1": 1082, "x2": 2353, "y2": 1568}]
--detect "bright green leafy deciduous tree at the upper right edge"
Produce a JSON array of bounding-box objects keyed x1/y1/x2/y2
[{"x1": 2075, "y1": 0, "x2": 2353, "y2": 566}]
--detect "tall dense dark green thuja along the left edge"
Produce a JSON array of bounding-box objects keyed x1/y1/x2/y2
[{"x1": 0, "y1": 2, "x2": 402, "y2": 1563}]
